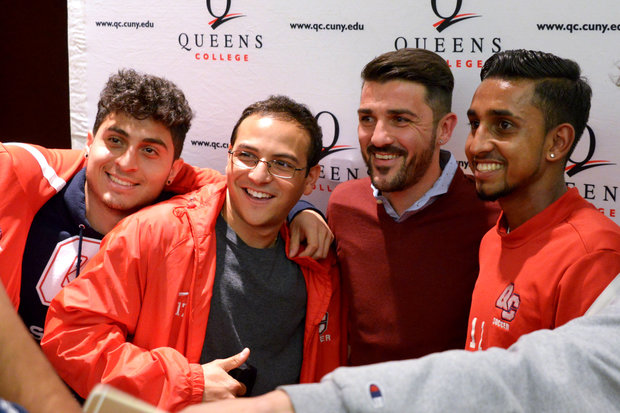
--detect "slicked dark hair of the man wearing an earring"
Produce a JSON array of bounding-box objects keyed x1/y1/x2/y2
[{"x1": 480, "y1": 49, "x2": 592, "y2": 159}]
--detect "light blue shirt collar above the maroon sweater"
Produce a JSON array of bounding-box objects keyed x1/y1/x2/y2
[{"x1": 370, "y1": 150, "x2": 458, "y2": 222}]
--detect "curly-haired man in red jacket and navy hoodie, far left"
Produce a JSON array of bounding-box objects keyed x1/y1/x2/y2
[{"x1": 0, "y1": 70, "x2": 208, "y2": 412}]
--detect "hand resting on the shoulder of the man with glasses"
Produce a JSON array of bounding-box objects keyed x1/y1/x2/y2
[{"x1": 289, "y1": 209, "x2": 334, "y2": 260}]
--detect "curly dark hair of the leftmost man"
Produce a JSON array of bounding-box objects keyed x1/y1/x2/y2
[{"x1": 93, "y1": 69, "x2": 194, "y2": 159}]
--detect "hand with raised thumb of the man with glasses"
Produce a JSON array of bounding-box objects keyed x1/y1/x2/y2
[{"x1": 202, "y1": 348, "x2": 250, "y2": 402}]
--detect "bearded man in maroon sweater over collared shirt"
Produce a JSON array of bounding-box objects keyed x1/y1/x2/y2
[{"x1": 327, "y1": 49, "x2": 499, "y2": 365}]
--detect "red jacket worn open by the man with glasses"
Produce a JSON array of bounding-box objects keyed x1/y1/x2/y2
[{"x1": 41, "y1": 180, "x2": 343, "y2": 410}]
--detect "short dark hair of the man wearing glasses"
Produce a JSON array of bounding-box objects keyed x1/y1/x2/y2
[{"x1": 230, "y1": 95, "x2": 323, "y2": 171}]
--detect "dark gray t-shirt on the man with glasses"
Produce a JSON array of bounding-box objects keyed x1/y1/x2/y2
[{"x1": 200, "y1": 216, "x2": 306, "y2": 396}]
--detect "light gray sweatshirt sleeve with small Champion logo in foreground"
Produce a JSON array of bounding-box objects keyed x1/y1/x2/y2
[{"x1": 282, "y1": 300, "x2": 620, "y2": 413}]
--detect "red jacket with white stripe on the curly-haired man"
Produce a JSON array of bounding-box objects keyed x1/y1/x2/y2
[{"x1": 0, "y1": 143, "x2": 220, "y2": 308}]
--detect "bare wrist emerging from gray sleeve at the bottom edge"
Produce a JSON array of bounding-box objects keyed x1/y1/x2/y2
[{"x1": 181, "y1": 390, "x2": 295, "y2": 413}]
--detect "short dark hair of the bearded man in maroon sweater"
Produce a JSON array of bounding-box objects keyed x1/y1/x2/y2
[{"x1": 362, "y1": 48, "x2": 454, "y2": 122}]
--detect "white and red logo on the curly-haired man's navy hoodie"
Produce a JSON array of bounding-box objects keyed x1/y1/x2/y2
[{"x1": 37, "y1": 235, "x2": 101, "y2": 306}]
